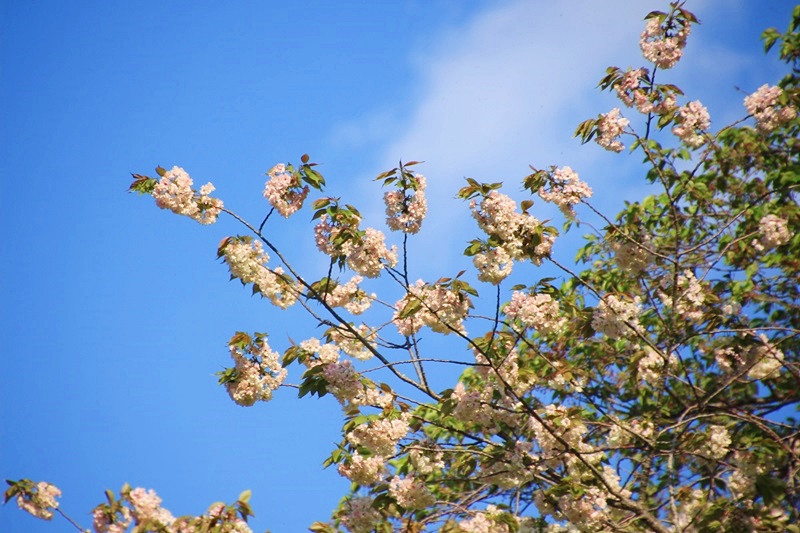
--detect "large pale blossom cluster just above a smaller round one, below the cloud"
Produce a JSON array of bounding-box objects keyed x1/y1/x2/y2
[{"x1": 470, "y1": 191, "x2": 555, "y2": 266}]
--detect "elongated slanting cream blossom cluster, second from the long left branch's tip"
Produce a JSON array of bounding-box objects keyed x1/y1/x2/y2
[{"x1": 222, "y1": 237, "x2": 300, "y2": 309}]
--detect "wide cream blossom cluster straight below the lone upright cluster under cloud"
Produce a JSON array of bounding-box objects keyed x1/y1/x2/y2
[{"x1": 392, "y1": 280, "x2": 472, "y2": 336}]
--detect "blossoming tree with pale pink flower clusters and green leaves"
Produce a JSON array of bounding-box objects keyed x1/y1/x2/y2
[{"x1": 6, "y1": 2, "x2": 800, "y2": 533}]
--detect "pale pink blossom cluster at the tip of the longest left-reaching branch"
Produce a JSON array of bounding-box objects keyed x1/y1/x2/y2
[{"x1": 153, "y1": 166, "x2": 222, "y2": 224}]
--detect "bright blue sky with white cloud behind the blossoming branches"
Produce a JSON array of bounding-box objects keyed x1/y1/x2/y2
[{"x1": 0, "y1": 0, "x2": 793, "y2": 533}]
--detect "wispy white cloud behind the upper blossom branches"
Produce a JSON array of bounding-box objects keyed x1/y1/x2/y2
[{"x1": 324, "y1": 0, "x2": 780, "y2": 270}]
